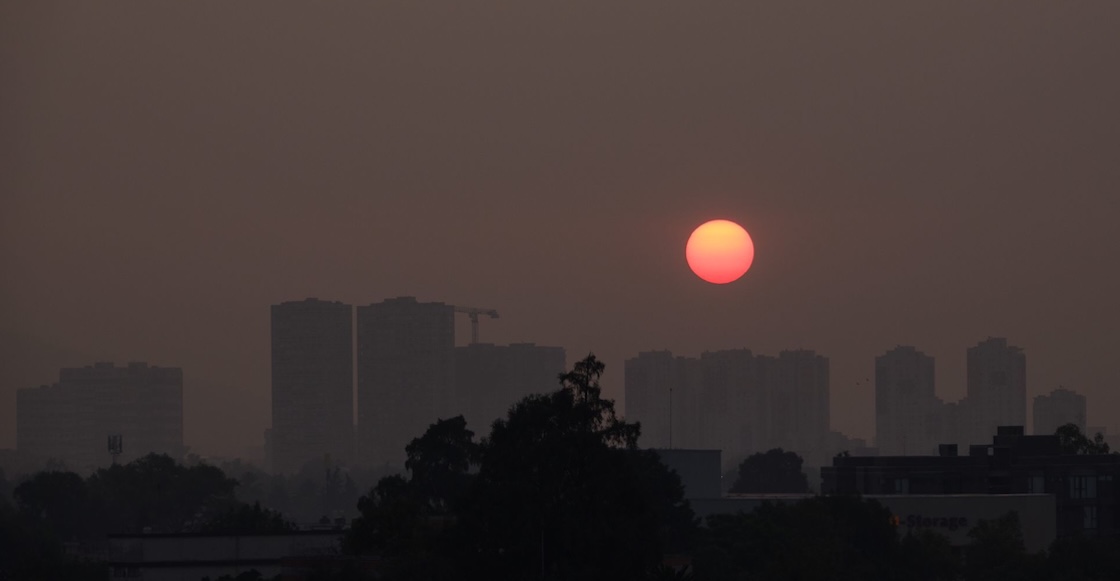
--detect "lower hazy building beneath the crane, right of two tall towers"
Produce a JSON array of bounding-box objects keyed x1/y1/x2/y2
[{"x1": 450, "y1": 343, "x2": 566, "y2": 437}]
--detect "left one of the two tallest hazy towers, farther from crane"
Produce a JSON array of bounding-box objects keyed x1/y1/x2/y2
[{"x1": 269, "y1": 298, "x2": 354, "y2": 474}]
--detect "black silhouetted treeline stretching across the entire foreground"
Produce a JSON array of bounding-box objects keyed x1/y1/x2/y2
[{"x1": 0, "y1": 356, "x2": 1120, "y2": 581}]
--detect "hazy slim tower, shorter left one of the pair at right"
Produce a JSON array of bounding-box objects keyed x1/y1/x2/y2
[{"x1": 875, "y1": 346, "x2": 946, "y2": 456}]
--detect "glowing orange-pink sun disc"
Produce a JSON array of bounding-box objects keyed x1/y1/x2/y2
[{"x1": 684, "y1": 219, "x2": 755, "y2": 284}]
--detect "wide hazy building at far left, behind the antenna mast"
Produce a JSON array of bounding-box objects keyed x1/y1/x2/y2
[{"x1": 16, "y1": 363, "x2": 184, "y2": 472}]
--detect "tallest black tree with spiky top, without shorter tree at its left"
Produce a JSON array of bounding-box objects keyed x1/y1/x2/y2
[{"x1": 472, "y1": 355, "x2": 693, "y2": 579}]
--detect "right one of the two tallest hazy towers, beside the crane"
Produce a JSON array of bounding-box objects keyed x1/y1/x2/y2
[{"x1": 357, "y1": 297, "x2": 458, "y2": 468}]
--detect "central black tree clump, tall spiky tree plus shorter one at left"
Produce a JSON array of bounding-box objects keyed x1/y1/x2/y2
[{"x1": 346, "y1": 356, "x2": 696, "y2": 579}]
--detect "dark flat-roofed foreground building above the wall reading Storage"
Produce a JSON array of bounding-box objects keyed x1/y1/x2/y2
[{"x1": 821, "y1": 425, "x2": 1120, "y2": 536}]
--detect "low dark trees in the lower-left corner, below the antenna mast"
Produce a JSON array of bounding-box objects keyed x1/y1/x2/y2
[{"x1": 0, "y1": 455, "x2": 293, "y2": 580}]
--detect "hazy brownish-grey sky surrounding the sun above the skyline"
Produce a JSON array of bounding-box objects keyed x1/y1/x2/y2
[{"x1": 0, "y1": 1, "x2": 1120, "y2": 453}]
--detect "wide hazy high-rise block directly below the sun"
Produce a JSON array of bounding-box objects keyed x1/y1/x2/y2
[{"x1": 625, "y1": 349, "x2": 840, "y2": 468}]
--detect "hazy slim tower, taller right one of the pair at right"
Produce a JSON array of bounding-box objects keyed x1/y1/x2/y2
[{"x1": 962, "y1": 338, "x2": 1027, "y2": 443}]
